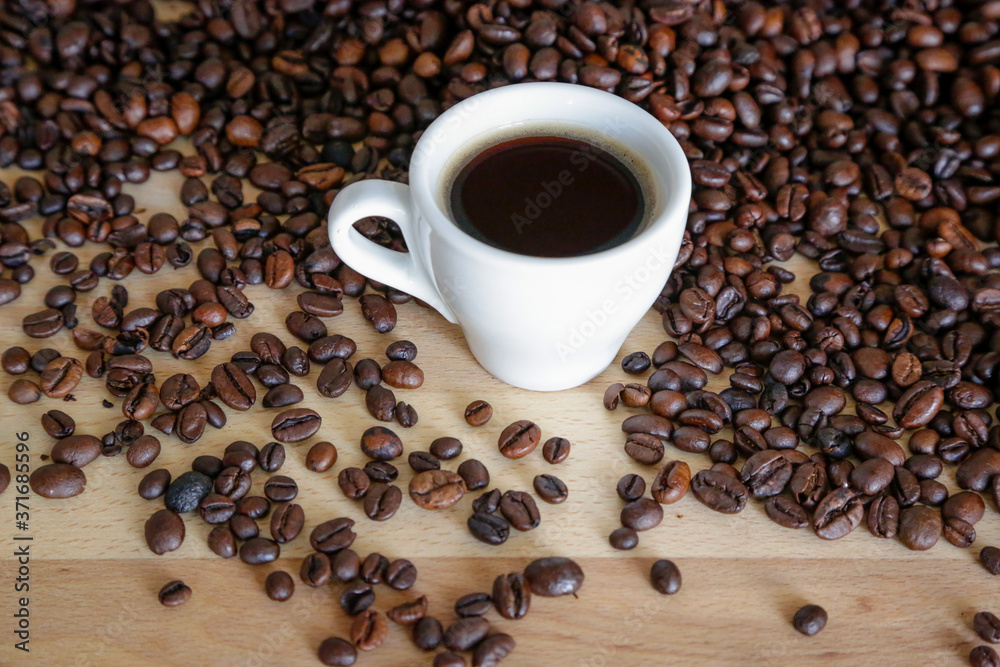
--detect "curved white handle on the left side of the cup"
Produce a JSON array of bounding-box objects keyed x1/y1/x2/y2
[{"x1": 328, "y1": 180, "x2": 457, "y2": 323}]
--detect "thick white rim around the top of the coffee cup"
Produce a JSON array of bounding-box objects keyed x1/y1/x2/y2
[{"x1": 410, "y1": 82, "x2": 691, "y2": 266}]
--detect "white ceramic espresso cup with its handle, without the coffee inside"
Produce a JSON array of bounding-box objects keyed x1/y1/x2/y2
[{"x1": 329, "y1": 83, "x2": 691, "y2": 391}]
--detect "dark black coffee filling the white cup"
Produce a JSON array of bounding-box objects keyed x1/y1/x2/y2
[{"x1": 449, "y1": 136, "x2": 646, "y2": 257}]
